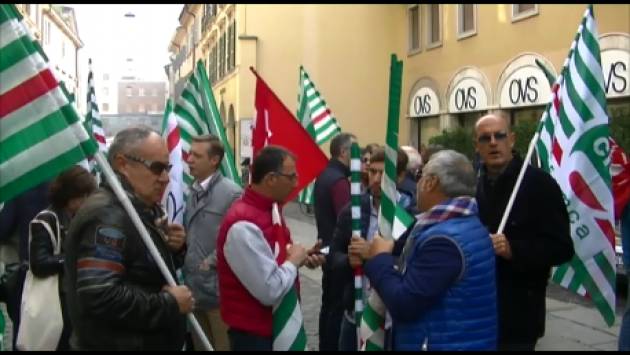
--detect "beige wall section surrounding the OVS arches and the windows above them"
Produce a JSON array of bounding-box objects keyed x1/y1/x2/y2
[{"x1": 401, "y1": 4, "x2": 630, "y2": 144}]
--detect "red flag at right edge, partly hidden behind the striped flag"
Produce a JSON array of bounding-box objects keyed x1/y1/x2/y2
[{"x1": 610, "y1": 138, "x2": 630, "y2": 219}]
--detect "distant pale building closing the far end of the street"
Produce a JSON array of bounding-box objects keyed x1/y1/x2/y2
[{"x1": 117, "y1": 81, "x2": 167, "y2": 115}]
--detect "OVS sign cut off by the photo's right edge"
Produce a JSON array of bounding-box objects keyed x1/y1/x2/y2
[{"x1": 601, "y1": 49, "x2": 630, "y2": 97}]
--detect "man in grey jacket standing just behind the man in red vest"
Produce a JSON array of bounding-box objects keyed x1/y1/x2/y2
[{"x1": 184, "y1": 135, "x2": 242, "y2": 351}]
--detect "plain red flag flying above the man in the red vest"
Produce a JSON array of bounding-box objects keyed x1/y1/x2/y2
[{"x1": 250, "y1": 67, "x2": 328, "y2": 203}]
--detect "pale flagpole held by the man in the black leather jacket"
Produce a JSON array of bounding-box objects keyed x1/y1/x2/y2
[{"x1": 94, "y1": 151, "x2": 214, "y2": 351}]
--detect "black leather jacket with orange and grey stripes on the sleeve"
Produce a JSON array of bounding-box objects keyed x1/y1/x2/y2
[{"x1": 64, "y1": 179, "x2": 186, "y2": 350}]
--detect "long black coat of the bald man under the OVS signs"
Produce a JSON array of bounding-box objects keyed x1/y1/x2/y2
[{"x1": 477, "y1": 156, "x2": 574, "y2": 344}]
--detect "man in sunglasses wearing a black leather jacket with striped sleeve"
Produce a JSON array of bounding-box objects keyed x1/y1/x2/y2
[{"x1": 64, "y1": 127, "x2": 194, "y2": 350}]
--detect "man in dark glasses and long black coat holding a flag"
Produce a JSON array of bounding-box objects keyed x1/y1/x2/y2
[{"x1": 474, "y1": 112, "x2": 574, "y2": 351}]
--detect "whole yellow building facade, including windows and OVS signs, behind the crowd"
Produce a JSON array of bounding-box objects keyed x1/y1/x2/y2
[{"x1": 169, "y1": 4, "x2": 630, "y2": 163}]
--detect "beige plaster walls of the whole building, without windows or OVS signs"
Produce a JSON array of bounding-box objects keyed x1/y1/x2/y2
[{"x1": 171, "y1": 4, "x2": 630, "y2": 160}]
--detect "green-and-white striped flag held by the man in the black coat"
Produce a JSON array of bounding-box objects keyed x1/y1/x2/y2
[{"x1": 536, "y1": 6, "x2": 616, "y2": 326}]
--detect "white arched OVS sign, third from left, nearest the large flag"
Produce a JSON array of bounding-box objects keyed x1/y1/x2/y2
[{"x1": 500, "y1": 67, "x2": 551, "y2": 107}]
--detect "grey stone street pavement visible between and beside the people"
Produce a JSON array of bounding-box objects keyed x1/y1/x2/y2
[{"x1": 284, "y1": 203, "x2": 625, "y2": 350}]
